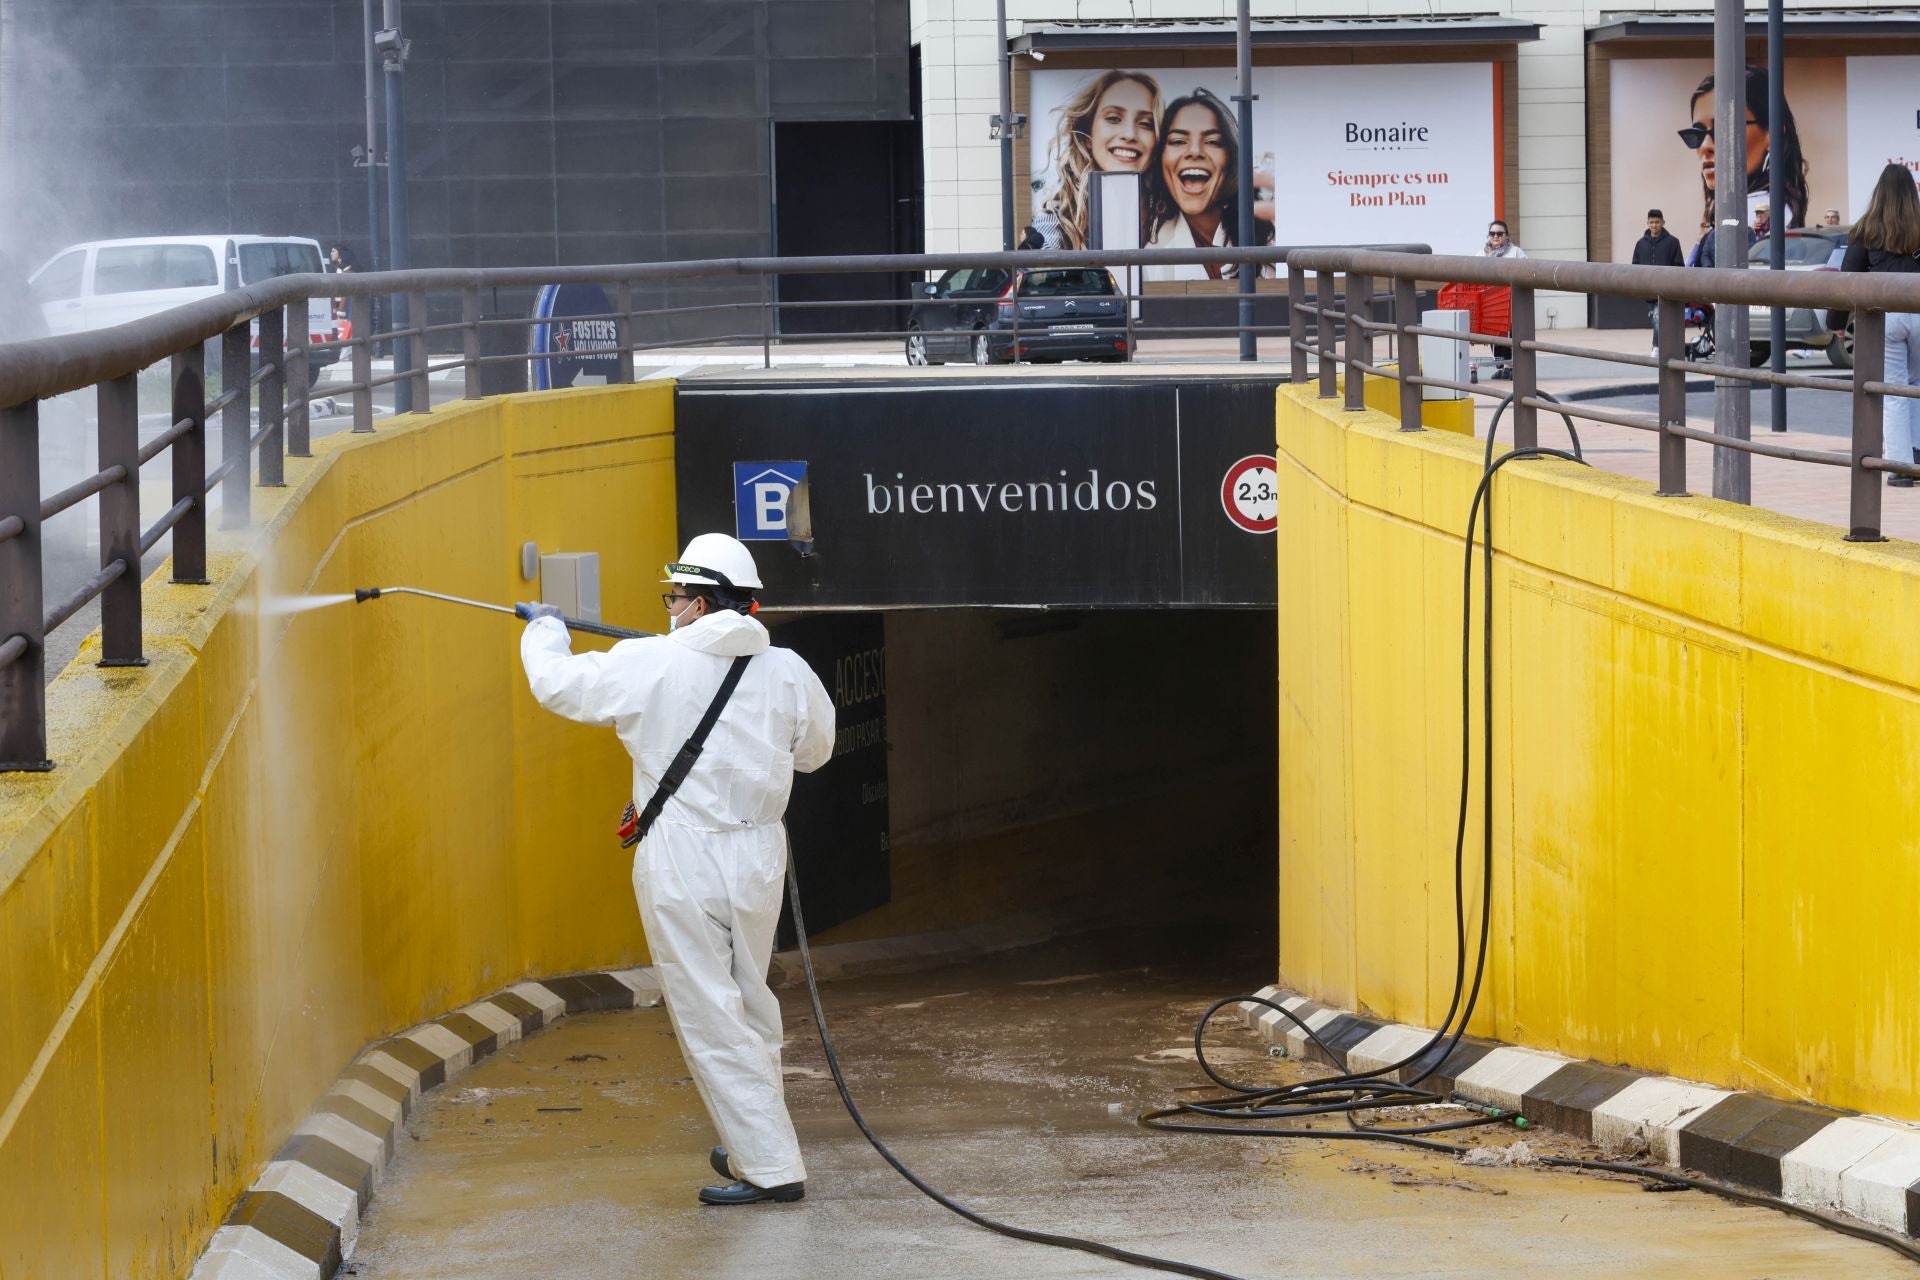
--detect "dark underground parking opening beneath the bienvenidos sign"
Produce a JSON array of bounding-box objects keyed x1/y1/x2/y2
[{"x1": 776, "y1": 608, "x2": 1279, "y2": 958}]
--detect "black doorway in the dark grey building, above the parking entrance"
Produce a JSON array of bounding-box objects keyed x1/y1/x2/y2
[{"x1": 774, "y1": 121, "x2": 922, "y2": 334}]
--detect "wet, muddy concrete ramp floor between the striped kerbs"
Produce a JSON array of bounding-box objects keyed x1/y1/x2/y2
[{"x1": 344, "y1": 931, "x2": 1912, "y2": 1280}]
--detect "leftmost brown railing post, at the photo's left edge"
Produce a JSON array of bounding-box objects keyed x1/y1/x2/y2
[{"x1": 0, "y1": 401, "x2": 54, "y2": 773}]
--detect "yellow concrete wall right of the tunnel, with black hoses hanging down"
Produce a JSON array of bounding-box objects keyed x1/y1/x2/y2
[{"x1": 1277, "y1": 388, "x2": 1920, "y2": 1119}]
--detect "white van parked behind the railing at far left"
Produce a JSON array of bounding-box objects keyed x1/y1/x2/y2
[{"x1": 31, "y1": 236, "x2": 340, "y2": 378}]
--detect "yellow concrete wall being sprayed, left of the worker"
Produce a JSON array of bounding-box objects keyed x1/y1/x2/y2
[{"x1": 0, "y1": 384, "x2": 676, "y2": 1280}]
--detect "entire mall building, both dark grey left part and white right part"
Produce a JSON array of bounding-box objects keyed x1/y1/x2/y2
[{"x1": 0, "y1": 0, "x2": 1920, "y2": 330}]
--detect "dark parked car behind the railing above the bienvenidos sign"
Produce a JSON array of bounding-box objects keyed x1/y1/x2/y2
[{"x1": 906, "y1": 267, "x2": 1133, "y2": 365}]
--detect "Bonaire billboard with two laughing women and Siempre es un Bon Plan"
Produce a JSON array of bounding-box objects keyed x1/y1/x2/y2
[{"x1": 1025, "y1": 61, "x2": 1501, "y2": 262}]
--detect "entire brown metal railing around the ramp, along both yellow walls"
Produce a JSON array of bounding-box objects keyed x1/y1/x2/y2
[{"x1": 0, "y1": 246, "x2": 1920, "y2": 782}]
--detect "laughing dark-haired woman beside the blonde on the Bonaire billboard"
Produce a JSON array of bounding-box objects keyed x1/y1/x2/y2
[{"x1": 1140, "y1": 88, "x2": 1275, "y2": 280}]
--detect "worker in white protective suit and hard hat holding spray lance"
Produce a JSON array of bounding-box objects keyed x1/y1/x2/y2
[{"x1": 520, "y1": 533, "x2": 833, "y2": 1205}]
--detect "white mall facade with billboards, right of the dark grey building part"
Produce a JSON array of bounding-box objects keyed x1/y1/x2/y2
[{"x1": 912, "y1": 0, "x2": 1920, "y2": 326}]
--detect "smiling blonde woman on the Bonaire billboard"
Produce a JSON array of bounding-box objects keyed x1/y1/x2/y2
[{"x1": 1020, "y1": 71, "x2": 1160, "y2": 249}]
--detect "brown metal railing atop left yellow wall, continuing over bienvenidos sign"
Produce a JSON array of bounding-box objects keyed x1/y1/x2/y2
[{"x1": 0, "y1": 246, "x2": 1425, "y2": 770}]
